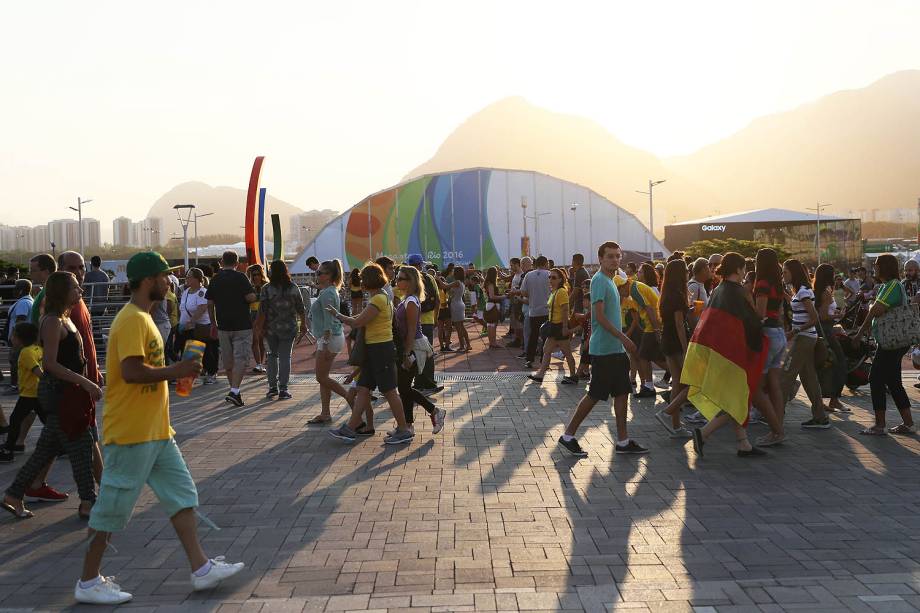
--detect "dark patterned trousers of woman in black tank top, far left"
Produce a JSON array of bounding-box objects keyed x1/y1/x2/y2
[{"x1": 6, "y1": 411, "x2": 96, "y2": 502}]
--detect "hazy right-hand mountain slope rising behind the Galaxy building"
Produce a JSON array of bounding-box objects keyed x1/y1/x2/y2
[{"x1": 665, "y1": 70, "x2": 920, "y2": 215}]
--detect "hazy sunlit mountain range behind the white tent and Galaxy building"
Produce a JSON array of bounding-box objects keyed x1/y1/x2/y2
[{"x1": 406, "y1": 70, "x2": 920, "y2": 234}]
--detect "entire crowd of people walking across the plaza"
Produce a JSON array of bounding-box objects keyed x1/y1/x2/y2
[{"x1": 0, "y1": 242, "x2": 920, "y2": 604}]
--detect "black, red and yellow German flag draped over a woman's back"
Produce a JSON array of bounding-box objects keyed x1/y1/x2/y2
[{"x1": 680, "y1": 281, "x2": 769, "y2": 424}]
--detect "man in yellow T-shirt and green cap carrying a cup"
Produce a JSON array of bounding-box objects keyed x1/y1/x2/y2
[{"x1": 74, "y1": 252, "x2": 243, "y2": 605}]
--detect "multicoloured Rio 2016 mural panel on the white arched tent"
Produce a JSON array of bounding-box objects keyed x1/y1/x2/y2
[{"x1": 345, "y1": 171, "x2": 500, "y2": 268}]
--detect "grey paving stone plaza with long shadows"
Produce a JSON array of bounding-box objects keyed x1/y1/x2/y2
[{"x1": 0, "y1": 374, "x2": 920, "y2": 613}]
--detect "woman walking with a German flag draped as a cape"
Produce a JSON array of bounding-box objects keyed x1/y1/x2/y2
[{"x1": 681, "y1": 253, "x2": 773, "y2": 457}]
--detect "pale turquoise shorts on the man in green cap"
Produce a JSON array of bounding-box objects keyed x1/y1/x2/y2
[{"x1": 89, "y1": 439, "x2": 198, "y2": 532}]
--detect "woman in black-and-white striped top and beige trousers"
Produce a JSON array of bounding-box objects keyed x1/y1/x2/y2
[{"x1": 782, "y1": 260, "x2": 831, "y2": 430}]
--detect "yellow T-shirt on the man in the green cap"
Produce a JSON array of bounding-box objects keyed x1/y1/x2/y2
[{"x1": 102, "y1": 302, "x2": 175, "y2": 445}]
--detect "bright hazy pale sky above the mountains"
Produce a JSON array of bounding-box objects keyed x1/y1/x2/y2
[{"x1": 0, "y1": 0, "x2": 920, "y2": 239}]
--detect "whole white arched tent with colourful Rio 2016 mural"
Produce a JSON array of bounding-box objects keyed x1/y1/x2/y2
[{"x1": 291, "y1": 168, "x2": 667, "y2": 273}]
